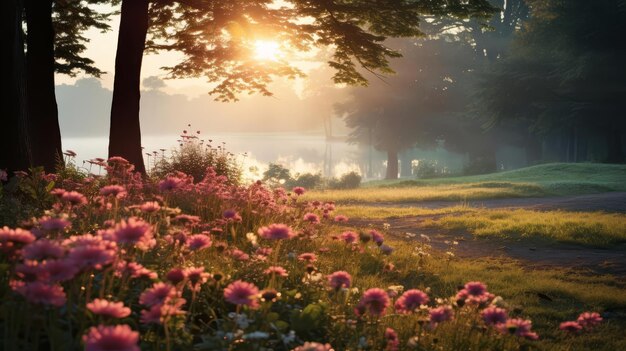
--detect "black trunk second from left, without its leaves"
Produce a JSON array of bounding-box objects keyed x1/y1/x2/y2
[{"x1": 25, "y1": 0, "x2": 63, "y2": 172}]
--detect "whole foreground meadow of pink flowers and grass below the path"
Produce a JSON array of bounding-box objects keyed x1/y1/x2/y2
[{"x1": 0, "y1": 158, "x2": 626, "y2": 351}]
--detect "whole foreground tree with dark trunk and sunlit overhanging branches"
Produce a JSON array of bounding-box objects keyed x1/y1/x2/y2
[{"x1": 109, "y1": 0, "x2": 492, "y2": 171}]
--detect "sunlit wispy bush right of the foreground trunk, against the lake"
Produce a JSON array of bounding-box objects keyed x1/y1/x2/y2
[{"x1": 150, "y1": 133, "x2": 241, "y2": 184}]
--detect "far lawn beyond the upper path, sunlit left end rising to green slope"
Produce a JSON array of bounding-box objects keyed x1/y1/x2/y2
[{"x1": 306, "y1": 163, "x2": 626, "y2": 203}]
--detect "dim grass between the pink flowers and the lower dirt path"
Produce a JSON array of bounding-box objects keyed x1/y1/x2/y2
[{"x1": 320, "y1": 234, "x2": 626, "y2": 350}]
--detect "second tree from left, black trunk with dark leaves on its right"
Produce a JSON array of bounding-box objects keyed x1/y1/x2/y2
[{"x1": 25, "y1": 0, "x2": 109, "y2": 172}]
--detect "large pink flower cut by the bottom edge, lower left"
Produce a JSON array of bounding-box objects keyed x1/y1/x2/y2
[{"x1": 83, "y1": 324, "x2": 141, "y2": 351}]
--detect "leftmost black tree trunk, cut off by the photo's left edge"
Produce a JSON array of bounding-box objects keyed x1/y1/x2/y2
[{"x1": 0, "y1": 0, "x2": 31, "y2": 175}]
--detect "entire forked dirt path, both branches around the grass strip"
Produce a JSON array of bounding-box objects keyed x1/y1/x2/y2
[{"x1": 347, "y1": 192, "x2": 626, "y2": 277}]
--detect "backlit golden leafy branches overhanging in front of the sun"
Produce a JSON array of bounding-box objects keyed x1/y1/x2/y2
[{"x1": 148, "y1": 0, "x2": 494, "y2": 101}]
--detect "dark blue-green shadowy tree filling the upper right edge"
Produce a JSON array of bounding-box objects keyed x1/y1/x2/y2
[{"x1": 483, "y1": 0, "x2": 626, "y2": 162}]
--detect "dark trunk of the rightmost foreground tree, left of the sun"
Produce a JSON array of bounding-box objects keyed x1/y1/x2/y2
[{"x1": 109, "y1": 0, "x2": 149, "y2": 173}]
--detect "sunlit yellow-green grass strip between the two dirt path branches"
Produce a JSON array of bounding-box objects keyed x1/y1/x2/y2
[{"x1": 341, "y1": 206, "x2": 626, "y2": 247}]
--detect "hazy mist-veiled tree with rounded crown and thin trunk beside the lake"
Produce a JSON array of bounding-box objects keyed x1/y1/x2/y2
[{"x1": 337, "y1": 37, "x2": 474, "y2": 179}]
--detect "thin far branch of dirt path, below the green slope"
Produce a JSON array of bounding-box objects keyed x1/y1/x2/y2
[{"x1": 359, "y1": 192, "x2": 626, "y2": 213}]
